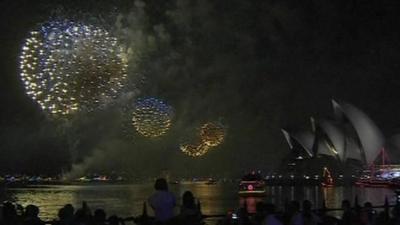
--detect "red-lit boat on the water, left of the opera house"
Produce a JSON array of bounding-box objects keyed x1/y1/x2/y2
[{"x1": 239, "y1": 171, "x2": 266, "y2": 197}]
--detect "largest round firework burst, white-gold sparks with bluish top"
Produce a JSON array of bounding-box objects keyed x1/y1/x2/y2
[{"x1": 20, "y1": 21, "x2": 127, "y2": 115}]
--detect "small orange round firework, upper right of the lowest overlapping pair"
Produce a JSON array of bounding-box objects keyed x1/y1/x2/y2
[{"x1": 200, "y1": 122, "x2": 225, "y2": 147}]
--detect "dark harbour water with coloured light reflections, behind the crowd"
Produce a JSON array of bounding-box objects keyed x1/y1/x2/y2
[{"x1": 0, "y1": 183, "x2": 395, "y2": 220}]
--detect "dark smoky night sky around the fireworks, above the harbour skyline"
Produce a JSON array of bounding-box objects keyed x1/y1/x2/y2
[{"x1": 0, "y1": 0, "x2": 400, "y2": 175}]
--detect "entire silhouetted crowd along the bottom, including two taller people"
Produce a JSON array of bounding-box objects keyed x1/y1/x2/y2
[{"x1": 0, "y1": 178, "x2": 400, "y2": 225}]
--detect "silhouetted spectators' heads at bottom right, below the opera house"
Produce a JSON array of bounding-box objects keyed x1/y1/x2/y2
[{"x1": 219, "y1": 200, "x2": 400, "y2": 225}]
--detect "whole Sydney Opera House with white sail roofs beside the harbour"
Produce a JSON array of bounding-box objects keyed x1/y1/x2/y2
[{"x1": 282, "y1": 100, "x2": 400, "y2": 178}]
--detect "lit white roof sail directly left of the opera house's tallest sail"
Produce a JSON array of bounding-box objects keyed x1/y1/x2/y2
[{"x1": 319, "y1": 120, "x2": 346, "y2": 161}]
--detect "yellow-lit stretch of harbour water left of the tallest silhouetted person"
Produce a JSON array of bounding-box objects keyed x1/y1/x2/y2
[{"x1": 4, "y1": 185, "x2": 156, "y2": 219}]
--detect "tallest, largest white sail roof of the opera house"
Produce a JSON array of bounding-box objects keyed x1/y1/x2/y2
[{"x1": 332, "y1": 100, "x2": 384, "y2": 164}]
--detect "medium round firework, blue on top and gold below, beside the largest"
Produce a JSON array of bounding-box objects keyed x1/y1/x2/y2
[{"x1": 132, "y1": 98, "x2": 173, "y2": 137}]
